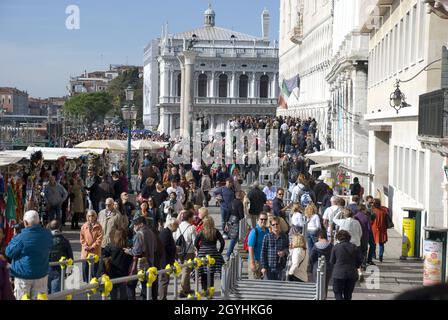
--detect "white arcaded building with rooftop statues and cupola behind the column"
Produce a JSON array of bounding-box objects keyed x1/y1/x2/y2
[{"x1": 143, "y1": 7, "x2": 279, "y2": 134}]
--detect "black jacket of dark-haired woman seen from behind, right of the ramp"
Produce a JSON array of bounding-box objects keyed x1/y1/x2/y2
[{"x1": 330, "y1": 241, "x2": 363, "y2": 280}]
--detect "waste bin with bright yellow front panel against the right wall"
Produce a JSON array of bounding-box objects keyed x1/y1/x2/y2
[{"x1": 400, "y1": 207, "x2": 423, "y2": 260}]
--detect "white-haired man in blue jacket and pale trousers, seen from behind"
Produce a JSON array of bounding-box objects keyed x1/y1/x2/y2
[{"x1": 6, "y1": 210, "x2": 53, "y2": 300}]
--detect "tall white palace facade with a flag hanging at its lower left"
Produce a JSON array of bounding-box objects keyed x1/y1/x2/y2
[{"x1": 277, "y1": 0, "x2": 333, "y2": 146}]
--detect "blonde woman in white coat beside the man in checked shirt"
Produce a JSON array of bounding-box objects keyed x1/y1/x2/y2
[{"x1": 288, "y1": 234, "x2": 309, "y2": 282}]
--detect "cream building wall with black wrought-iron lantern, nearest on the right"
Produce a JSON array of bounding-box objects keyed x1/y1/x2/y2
[{"x1": 361, "y1": 0, "x2": 448, "y2": 240}]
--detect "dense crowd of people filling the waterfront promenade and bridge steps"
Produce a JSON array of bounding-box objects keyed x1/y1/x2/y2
[{"x1": 0, "y1": 117, "x2": 387, "y2": 300}]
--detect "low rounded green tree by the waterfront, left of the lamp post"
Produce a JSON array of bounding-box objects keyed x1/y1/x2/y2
[{"x1": 64, "y1": 92, "x2": 113, "y2": 123}]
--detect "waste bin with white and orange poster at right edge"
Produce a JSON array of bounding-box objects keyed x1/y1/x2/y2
[{"x1": 423, "y1": 227, "x2": 448, "y2": 286}]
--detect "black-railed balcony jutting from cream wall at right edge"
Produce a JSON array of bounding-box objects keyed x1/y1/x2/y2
[{"x1": 418, "y1": 89, "x2": 448, "y2": 155}]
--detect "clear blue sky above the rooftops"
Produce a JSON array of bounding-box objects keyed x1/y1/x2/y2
[{"x1": 0, "y1": 0, "x2": 279, "y2": 98}]
